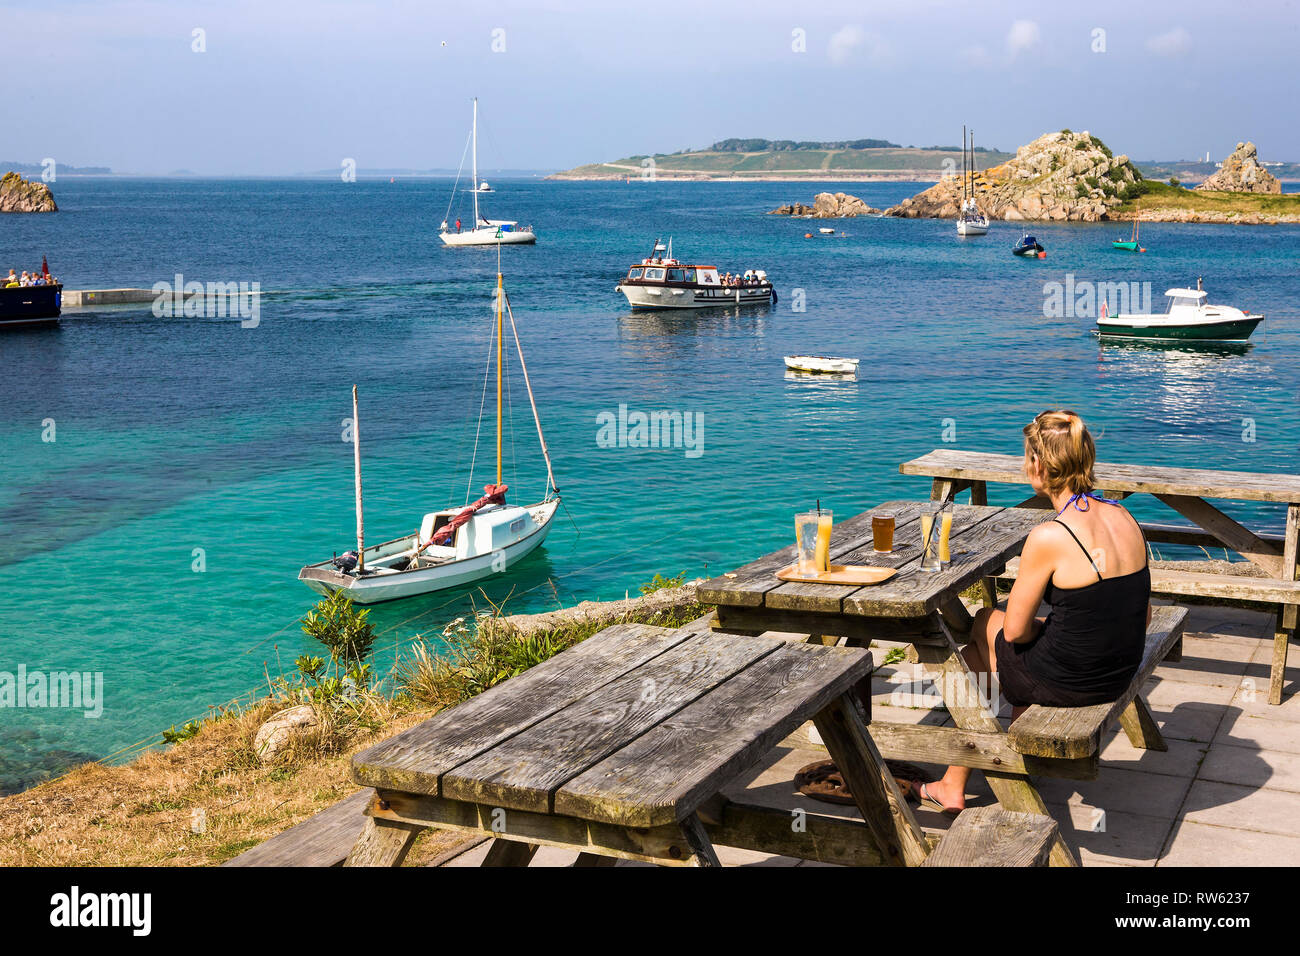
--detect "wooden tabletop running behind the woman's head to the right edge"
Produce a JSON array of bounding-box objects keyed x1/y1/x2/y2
[{"x1": 898, "y1": 449, "x2": 1300, "y2": 503}]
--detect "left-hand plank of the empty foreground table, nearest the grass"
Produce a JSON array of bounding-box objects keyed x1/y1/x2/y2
[{"x1": 352, "y1": 622, "x2": 707, "y2": 795}]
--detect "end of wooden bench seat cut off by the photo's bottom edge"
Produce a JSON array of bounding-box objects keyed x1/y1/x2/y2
[{"x1": 922, "y1": 806, "x2": 1060, "y2": 866}]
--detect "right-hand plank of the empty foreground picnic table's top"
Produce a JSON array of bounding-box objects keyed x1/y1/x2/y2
[{"x1": 555, "y1": 644, "x2": 871, "y2": 827}]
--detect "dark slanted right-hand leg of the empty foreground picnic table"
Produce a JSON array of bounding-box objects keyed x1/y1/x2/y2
[{"x1": 813, "y1": 695, "x2": 930, "y2": 866}]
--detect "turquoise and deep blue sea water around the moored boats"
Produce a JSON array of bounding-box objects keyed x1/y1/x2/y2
[{"x1": 0, "y1": 179, "x2": 1300, "y2": 791}]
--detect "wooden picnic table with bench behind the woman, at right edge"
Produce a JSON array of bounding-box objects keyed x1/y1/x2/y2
[{"x1": 900, "y1": 449, "x2": 1300, "y2": 704}]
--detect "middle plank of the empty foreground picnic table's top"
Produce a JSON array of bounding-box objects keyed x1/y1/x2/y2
[{"x1": 442, "y1": 633, "x2": 783, "y2": 813}]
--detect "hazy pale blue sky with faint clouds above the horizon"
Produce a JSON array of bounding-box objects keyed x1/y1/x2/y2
[{"x1": 0, "y1": 0, "x2": 1300, "y2": 176}]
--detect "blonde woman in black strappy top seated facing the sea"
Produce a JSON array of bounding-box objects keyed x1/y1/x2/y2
[{"x1": 918, "y1": 410, "x2": 1151, "y2": 813}]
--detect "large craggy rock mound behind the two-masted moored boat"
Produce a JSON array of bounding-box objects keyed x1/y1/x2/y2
[{"x1": 885, "y1": 130, "x2": 1141, "y2": 222}]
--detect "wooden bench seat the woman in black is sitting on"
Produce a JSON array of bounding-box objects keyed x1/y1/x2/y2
[{"x1": 1008, "y1": 607, "x2": 1187, "y2": 760}]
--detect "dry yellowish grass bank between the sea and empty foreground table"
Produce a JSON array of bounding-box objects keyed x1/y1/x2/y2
[{"x1": 0, "y1": 575, "x2": 710, "y2": 866}]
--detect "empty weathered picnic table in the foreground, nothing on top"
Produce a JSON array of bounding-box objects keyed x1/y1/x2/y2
[{"x1": 347, "y1": 620, "x2": 930, "y2": 866}]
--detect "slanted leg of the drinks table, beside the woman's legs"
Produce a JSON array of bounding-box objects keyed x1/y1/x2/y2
[{"x1": 915, "y1": 614, "x2": 1079, "y2": 866}]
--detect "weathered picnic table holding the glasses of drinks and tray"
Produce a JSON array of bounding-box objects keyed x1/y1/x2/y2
[{"x1": 697, "y1": 501, "x2": 1097, "y2": 866}]
